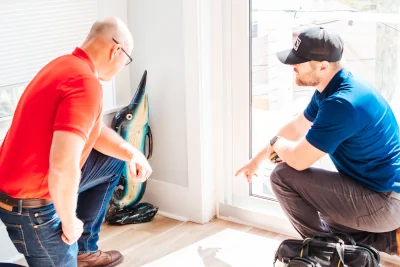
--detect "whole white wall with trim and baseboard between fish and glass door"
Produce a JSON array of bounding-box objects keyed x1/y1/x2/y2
[{"x1": 128, "y1": 0, "x2": 217, "y2": 223}]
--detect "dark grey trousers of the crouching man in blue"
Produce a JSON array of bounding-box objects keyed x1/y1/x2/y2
[{"x1": 271, "y1": 163, "x2": 400, "y2": 254}]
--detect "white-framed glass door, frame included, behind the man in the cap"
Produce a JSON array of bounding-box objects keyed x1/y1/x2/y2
[{"x1": 225, "y1": 0, "x2": 400, "y2": 229}]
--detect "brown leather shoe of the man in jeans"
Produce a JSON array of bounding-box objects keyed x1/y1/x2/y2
[{"x1": 78, "y1": 250, "x2": 124, "y2": 267}]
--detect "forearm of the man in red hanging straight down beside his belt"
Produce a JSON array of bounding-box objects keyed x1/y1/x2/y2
[{"x1": 48, "y1": 167, "x2": 81, "y2": 223}]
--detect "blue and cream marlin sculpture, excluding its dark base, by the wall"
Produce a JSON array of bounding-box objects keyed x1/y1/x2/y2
[{"x1": 106, "y1": 70, "x2": 153, "y2": 211}]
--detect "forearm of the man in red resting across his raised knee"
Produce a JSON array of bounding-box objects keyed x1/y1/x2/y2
[{"x1": 94, "y1": 125, "x2": 136, "y2": 161}]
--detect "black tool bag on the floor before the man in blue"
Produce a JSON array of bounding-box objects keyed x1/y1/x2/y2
[{"x1": 274, "y1": 234, "x2": 380, "y2": 267}]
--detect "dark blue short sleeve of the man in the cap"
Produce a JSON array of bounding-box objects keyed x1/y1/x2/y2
[{"x1": 306, "y1": 99, "x2": 358, "y2": 154}]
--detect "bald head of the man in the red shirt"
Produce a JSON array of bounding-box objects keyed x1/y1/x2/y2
[{"x1": 81, "y1": 17, "x2": 133, "y2": 81}]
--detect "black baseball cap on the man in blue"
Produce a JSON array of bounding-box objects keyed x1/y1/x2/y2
[{"x1": 276, "y1": 27, "x2": 343, "y2": 65}]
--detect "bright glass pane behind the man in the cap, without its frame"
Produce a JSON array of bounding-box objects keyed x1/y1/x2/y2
[{"x1": 250, "y1": 1, "x2": 400, "y2": 201}]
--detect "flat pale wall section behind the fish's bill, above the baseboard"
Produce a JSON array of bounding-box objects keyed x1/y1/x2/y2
[{"x1": 128, "y1": 0, "x2": 188, "y2": 187}]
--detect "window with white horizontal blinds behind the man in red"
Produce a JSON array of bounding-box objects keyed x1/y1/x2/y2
[{"x1": 0, "y1": 0, "x2": 115, "y2": 142}]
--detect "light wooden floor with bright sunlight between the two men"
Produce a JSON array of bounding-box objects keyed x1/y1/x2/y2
[{"x1": 18, "y1": 216, "x2": 399, "y2": 267}]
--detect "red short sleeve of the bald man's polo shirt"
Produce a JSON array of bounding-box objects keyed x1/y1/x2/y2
[{"x1": 53, "y1": 78, "x2": 103, "y2": 142}]
